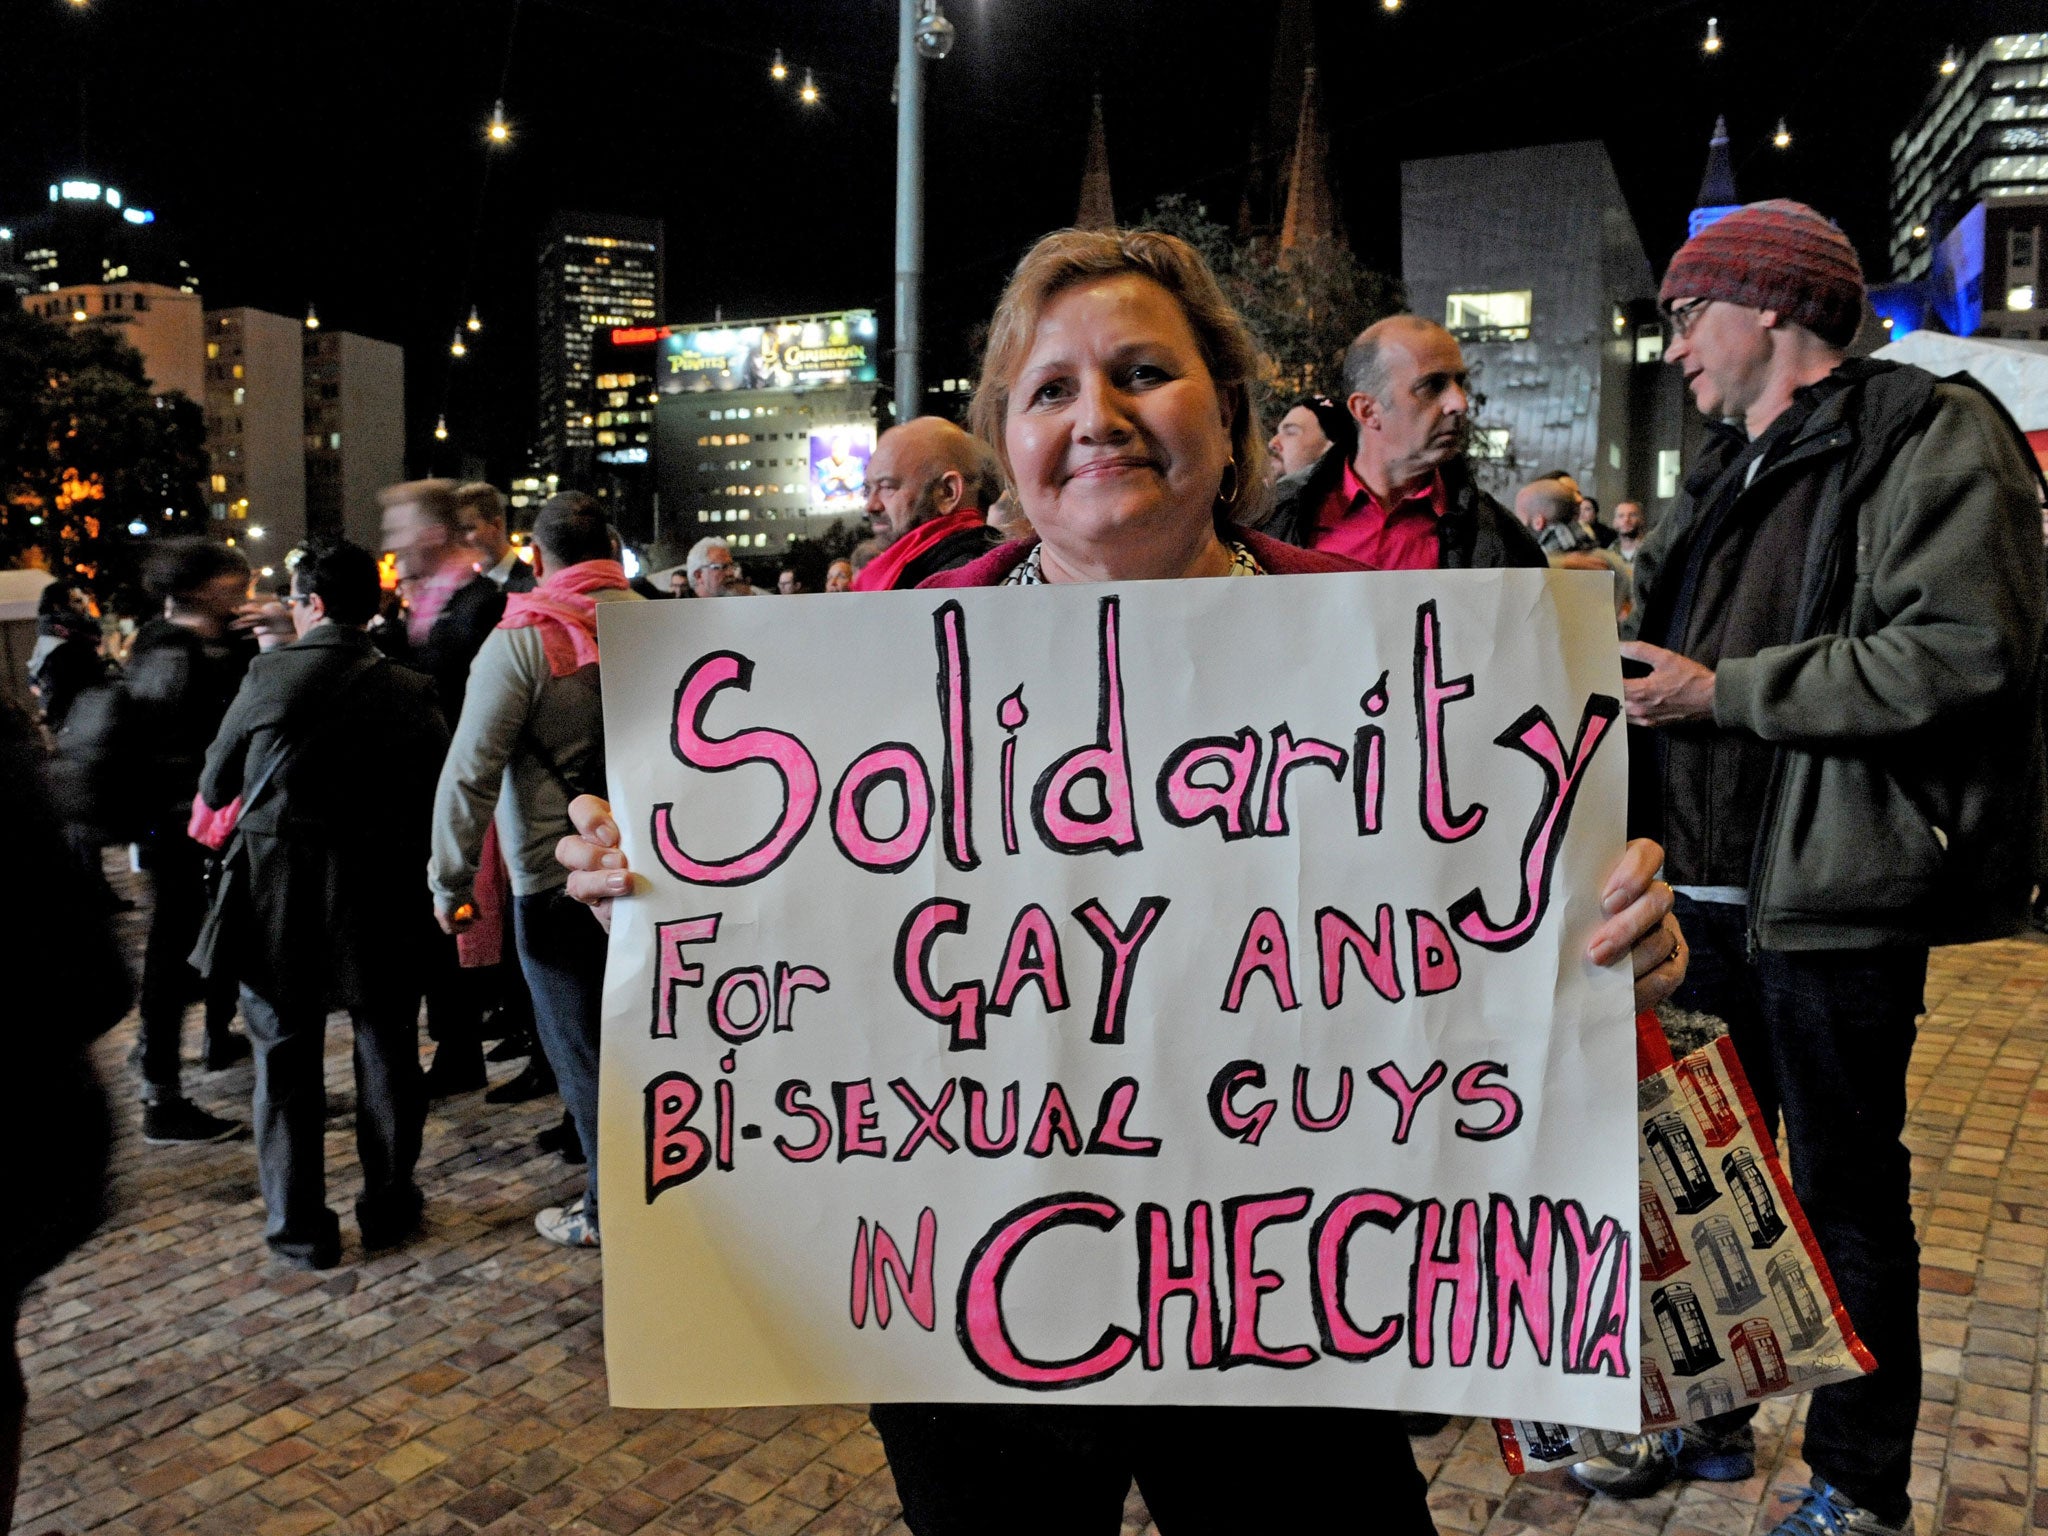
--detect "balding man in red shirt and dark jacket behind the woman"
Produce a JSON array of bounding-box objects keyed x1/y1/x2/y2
[{"x1": 1268, "y1": 315, "x2": 1546, "y2": 571}]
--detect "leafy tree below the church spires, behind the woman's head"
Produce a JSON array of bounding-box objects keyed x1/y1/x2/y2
[{"x1": 1139, "y1": 193, "x2": 1403, "y2": 422}]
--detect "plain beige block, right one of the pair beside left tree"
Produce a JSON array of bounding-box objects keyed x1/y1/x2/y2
[{"x1": 301, "y1": 328, "x2": 406, "y2": 549}]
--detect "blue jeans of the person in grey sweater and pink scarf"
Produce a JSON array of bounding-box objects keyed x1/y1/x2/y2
[{"x1": 512, "y1": 891, "x2": 606, "y2": 1225}]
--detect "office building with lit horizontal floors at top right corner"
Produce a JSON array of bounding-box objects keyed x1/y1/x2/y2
[{"x1": 1890, "y1": 33, "x2": 2048, "y2": 280}]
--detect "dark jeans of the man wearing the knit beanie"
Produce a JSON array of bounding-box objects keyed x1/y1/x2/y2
[{"x1": 1671, "y1": 895, "x2": 1927, "y2": 1526}]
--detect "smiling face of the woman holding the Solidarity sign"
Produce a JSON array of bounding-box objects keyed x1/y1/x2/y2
[{"x1": 1004, "y1": 274, "x2": 1231, "y2": 553}]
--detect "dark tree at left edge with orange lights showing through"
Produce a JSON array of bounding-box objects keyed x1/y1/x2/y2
[{"x1": 0, "y1": 309, "x2": 207, "y2": 575}]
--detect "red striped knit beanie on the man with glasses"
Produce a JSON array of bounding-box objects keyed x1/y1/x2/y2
[{"x1": 1657, "y1": 199, "x2": 1864, "y2": 346}]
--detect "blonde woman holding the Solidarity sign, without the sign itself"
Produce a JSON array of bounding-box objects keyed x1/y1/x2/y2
[{"x1": 557, "y1": 229, "x2": 1686, "y2": 1536}]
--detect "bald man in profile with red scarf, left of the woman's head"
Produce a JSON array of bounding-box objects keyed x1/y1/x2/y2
[{"x1": 854, "y1": 416, "x2": 1004, "y2": 592}]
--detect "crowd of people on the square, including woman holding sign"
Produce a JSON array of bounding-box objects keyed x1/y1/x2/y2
[{"x1": 16, "y1": 203, "x2": 2048, "y2": 1536}]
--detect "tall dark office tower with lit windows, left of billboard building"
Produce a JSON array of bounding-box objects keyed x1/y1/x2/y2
[{"x1": 537, "y1": 213, "x2": 662, "y2": 483}]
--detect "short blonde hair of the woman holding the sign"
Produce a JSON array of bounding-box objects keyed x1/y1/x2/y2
[{"x1": 967, "y1": 229, "x2": 1266, "y2": 528}]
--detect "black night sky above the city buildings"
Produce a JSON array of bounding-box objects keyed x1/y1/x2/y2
[{"x1": 0, "y1": 0, "x2": 2048, "y2": 481}]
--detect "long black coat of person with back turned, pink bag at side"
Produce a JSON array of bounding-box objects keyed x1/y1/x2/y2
[{"x1": 193, "y1": 625, "x2": 449, "y2": 1012}]
